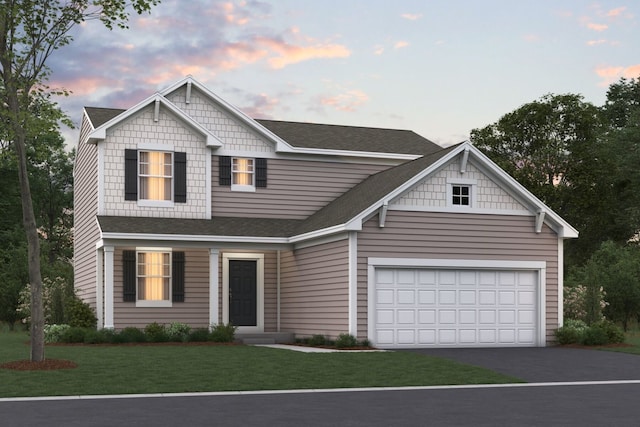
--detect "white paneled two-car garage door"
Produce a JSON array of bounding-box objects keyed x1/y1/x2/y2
[{"x1": 374, "y1": 268, "x2": 538, "y2": 348}]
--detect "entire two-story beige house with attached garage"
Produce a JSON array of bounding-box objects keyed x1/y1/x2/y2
[{"x1": 74, "y1": 77, "x2": 577, "y2": 348}]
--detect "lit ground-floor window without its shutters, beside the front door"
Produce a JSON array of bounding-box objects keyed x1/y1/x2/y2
[{"x1": 137, "y1": 252, "x2": 171, "y2": 302}]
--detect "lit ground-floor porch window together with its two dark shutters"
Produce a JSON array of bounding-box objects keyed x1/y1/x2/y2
[{"x1": 122, "y1": 248, "x2": 185, "y2": 307}]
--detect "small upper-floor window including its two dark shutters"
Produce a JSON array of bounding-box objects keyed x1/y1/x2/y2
[{"x1": 218, "y1": 156, "x2": 267, "y2": 191}]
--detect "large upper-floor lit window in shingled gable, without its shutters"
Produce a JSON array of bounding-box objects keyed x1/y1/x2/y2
[{"x1": 138, "y1": 151, "x2": 173, "y2": 201}]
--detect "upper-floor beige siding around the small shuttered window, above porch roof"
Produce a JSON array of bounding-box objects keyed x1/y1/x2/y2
[{"x1": 211, "y1": 156, "x2": 388, "y2": 219}]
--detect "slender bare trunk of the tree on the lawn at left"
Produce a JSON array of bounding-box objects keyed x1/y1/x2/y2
[{"x1": 10, "y1": 112, "x2": 44, "y2": 362}]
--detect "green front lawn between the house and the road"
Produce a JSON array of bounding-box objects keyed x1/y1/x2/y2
[{"x1": 0, "y1": 332, "x2": 520, "y2": 397}]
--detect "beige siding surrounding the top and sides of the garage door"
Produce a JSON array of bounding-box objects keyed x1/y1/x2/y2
[{"x1": 358, "y1": 211, "x2": 558, "y2": 341}]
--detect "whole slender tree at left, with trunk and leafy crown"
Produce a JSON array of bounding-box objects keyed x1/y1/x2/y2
[{"x1": 0, "y1": 0, "x2": 160, "y2": 361}]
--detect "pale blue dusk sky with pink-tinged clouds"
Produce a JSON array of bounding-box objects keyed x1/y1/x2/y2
[{"x1": 48, "y1": 0, "x2": 640, "y2": 146}]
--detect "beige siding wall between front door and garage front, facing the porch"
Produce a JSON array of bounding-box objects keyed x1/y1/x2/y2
[{"x1": 280, "y1": 240, "x2": 349, "y2": 338}]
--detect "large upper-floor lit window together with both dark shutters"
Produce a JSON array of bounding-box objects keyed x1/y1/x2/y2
[{"x1": 124, "y1": 147, "x2": 187, "y2": 207}]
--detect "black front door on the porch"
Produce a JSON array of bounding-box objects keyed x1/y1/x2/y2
[{"x1": 229, "y1": 260, "x2": 258, "y2": 326}]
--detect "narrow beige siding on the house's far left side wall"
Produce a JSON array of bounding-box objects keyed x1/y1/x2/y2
[{"x1": 73, "y1": 117, "x2": 99, "y2": 309}]
